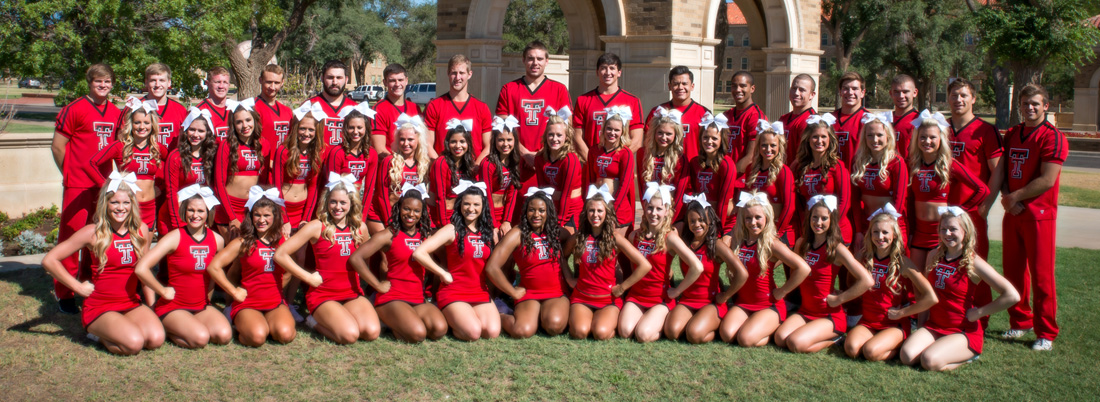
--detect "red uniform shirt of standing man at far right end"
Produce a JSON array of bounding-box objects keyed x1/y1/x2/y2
[{"x1": 1004, "y1": 121, "x2": 1069, "y2": 220}]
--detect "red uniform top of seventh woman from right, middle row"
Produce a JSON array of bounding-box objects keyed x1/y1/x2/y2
[{"x1": 584, "y1": 145, "x2": 638, "y2": 226}]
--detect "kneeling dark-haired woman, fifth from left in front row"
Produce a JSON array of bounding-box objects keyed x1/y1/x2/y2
[{"x1": 348, "y1": 183, "x2": 447, "y2": 344}]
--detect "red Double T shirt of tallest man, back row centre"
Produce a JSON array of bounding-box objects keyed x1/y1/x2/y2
[{"x1": 496, "y1": 77, "x2": 570, "y2": 152}]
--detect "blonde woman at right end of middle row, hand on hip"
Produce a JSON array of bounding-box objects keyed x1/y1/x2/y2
[{"x1": 909, "y1": 110, "x2": 989, "y2": 269}]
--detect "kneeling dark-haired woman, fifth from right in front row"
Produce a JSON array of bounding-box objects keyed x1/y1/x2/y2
[{"x1": 664, "y1": 195, "x2": 748, "y2": 344}]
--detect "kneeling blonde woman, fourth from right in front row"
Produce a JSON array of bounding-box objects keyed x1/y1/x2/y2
[{"x1": 718, "y1": 192, "x2": 810, "y2": 347}]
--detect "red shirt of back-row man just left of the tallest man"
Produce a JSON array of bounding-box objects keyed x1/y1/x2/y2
[{"x1": 424, "y1": 93, "x2": 493, "y2": 159}]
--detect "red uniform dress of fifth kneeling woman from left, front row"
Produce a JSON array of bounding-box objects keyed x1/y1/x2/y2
[{"x1": 374, "y1": 230, "x2": 429, "y2": 306}]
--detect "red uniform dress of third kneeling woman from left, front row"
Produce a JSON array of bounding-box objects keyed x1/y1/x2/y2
[{"x1": 229, "y1": 236, "x2": 284, "y2": 319}]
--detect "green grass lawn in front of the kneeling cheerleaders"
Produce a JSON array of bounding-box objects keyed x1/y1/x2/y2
[{"x1": 0, "y1": 243, "x2": 1100, "y2": 401}]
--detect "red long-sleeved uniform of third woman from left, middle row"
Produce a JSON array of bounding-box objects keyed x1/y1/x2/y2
[{"x1": 212, "y1": 139, "x2": 272, "y2": 225}]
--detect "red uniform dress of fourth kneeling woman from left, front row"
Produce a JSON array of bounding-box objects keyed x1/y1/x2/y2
[{"x1": 306, "y1": 226, "x2": 363, "y2": 313}]
